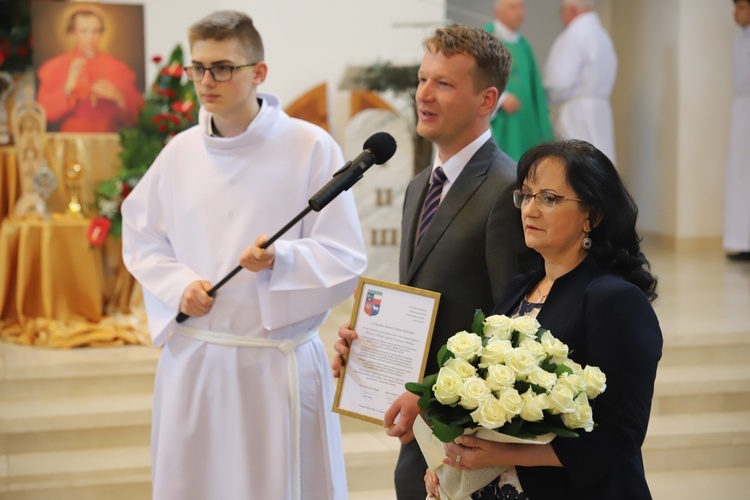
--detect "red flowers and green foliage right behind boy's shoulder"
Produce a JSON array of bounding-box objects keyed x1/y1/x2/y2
[{"x1": 88, "y1": 45, "x2": 197, "y2": 246}]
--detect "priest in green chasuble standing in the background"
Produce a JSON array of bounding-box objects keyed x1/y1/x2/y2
[{"x1": 485, "y1": 0, "x2": 554, "y2": 161}]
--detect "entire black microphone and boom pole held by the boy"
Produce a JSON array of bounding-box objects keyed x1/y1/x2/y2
[{"x1": 175, "y1": 132, "x2": 396, "y2": 323}]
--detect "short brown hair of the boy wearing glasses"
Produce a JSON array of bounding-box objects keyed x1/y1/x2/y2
[{"x1": 188, "y1": 10, "x2": 264, "y2": 63}]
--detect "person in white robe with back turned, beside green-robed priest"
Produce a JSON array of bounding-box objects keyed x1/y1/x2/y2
[{"x1": 544, "y1": 0, "x2": 617, "y2": 163}]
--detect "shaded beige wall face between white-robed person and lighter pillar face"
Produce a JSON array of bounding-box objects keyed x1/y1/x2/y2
[{"x1": 610, "y1": 0, "x2": 679, "y2": 237}]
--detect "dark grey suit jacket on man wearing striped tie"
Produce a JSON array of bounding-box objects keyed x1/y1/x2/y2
[{"x1": 396, "y1": 138, "x2": 523, "y2": 500}]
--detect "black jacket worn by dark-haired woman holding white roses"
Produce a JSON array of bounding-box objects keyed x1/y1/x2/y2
[{"x1": 495, "y1": 259, "x2": 662, "y2": 500}]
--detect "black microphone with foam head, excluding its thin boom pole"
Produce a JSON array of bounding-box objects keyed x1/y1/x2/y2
[{"x1": 308, "y1": 132, "x2": 396, "y2": 212}]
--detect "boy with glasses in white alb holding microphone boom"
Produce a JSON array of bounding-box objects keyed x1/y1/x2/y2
[{"x1": 122, "y1": 11, "x2": 366, "y2": 500}]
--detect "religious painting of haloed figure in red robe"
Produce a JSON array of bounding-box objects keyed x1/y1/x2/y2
[{"x1": 31, "y1": 1, "x2": 146, "y2": 133}]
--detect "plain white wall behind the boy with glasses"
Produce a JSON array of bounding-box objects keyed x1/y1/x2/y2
[{"x1": 112, "y1": 0, "x2": 445, "y2": 139}]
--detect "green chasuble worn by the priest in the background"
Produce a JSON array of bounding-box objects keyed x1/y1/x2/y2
[{"x1": 485, "y1": 23, "x2": 554, "y2": 161}]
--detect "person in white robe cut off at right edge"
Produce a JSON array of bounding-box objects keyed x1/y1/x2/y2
[{"x1": 724, "y1": 0, "x2": 750, "y2": 260}]
